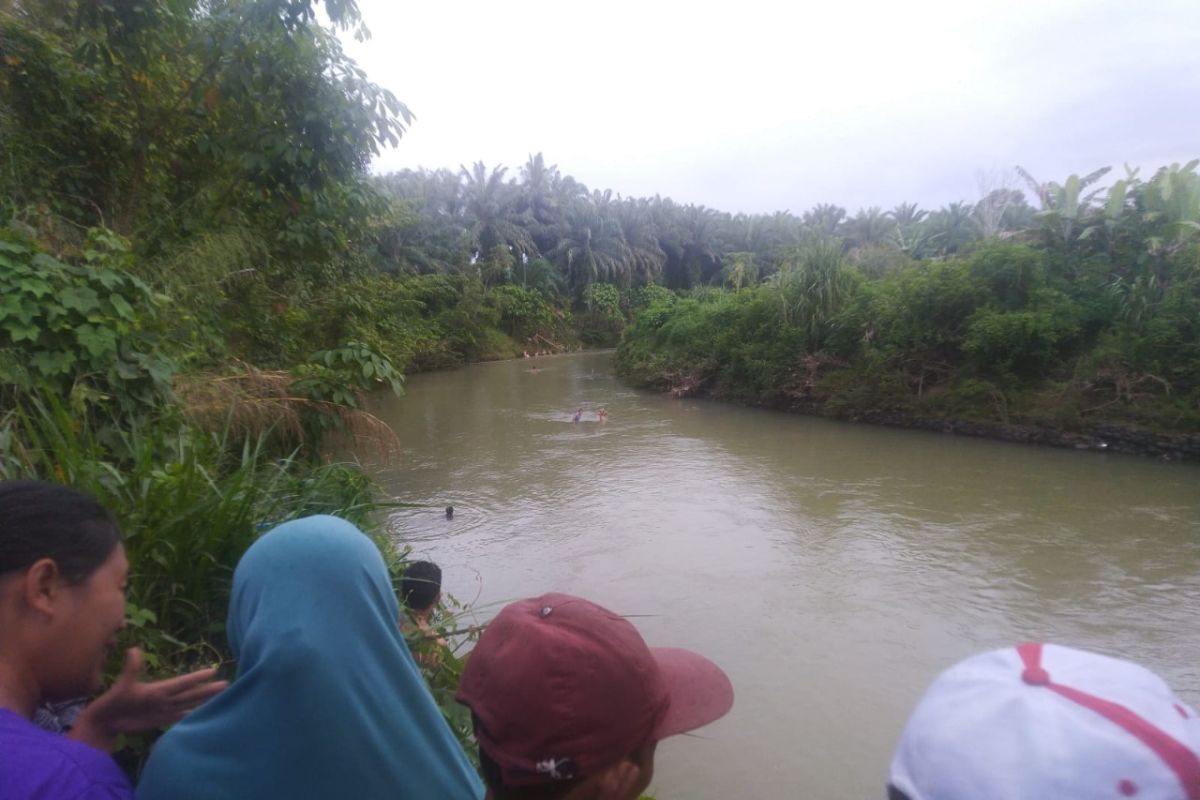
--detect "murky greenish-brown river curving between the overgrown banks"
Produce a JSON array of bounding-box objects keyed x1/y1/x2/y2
[{"x1": 362, "y1": 353, "x2": 1200, "y2": 800}]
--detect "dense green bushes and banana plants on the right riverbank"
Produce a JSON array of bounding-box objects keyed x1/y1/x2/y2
[{"x1": 618, "y1": 162, "x2": 1200, "y2": 432}]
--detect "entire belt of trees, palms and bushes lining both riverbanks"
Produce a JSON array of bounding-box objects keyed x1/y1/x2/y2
[{"x1": 0, "y1": 0, "x2": 1200, "y2": 782}]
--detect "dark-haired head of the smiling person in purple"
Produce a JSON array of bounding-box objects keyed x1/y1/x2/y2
[{"x1": 0, "y1": 480, "x2": 128, "y2": 717}]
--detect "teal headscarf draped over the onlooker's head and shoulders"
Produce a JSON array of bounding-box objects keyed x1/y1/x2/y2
[{"x1": 137, "y1": 517, "x2": 484, "y2": 800}]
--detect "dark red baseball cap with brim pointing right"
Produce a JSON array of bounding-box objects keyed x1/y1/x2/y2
[{"x1": 455, "y1": 594, "x2": 733, "y2": 786}]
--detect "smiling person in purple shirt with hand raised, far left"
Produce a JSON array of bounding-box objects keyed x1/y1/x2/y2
[{"x1": 0, "y1": 481, "x2": 224, "y2": 800}]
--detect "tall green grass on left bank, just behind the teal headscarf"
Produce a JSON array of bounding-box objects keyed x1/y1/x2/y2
[{"x1": 0, "y1": 395, "x2": 376, "y2": 669}]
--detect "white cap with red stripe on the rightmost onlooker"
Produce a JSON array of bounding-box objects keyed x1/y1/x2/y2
[{"x1": 888, "y1": 644, "x2": 1200, "y2": 800}]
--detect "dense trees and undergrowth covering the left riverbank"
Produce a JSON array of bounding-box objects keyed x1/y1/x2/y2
[{"x1": 0, "y1": 0, "x2": 477, "y2": 768}]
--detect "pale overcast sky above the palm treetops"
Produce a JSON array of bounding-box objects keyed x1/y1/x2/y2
[{"x1": 343, "y1": 0, "x2": 1200, "y2": 212}]
